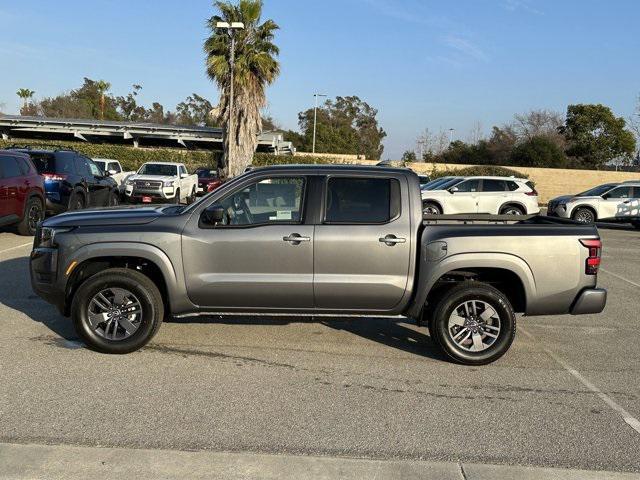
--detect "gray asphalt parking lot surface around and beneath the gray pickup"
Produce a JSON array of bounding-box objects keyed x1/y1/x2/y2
[{"x1": 0, "y1": 227, "x2": 640, "y2": 472}]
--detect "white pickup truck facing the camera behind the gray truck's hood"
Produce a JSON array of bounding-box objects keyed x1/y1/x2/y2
[{"x1": 124, "y1": 162, "x2": 198, "y2": 203}]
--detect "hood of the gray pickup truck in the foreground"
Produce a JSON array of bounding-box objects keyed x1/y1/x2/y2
[{"x1": 43, "y1": 205, "x2": 175, "y2": 227}]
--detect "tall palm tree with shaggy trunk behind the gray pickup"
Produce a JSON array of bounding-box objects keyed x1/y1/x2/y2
[{"x1": 204, "y1": 0, "x2": 280, "y2": 177}]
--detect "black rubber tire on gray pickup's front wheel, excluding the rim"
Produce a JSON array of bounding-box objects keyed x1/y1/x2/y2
[{"x1": 71, "y1": 268, "x2": 164, "y2": 354}]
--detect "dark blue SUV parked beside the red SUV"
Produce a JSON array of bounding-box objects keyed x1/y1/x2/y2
[{"x1": 12, "y1": 149, "x2": 120, "y2": 214}]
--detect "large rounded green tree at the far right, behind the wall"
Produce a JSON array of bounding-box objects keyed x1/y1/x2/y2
[{"x1": 561, "y1": 104, "x2": 636, "y2": 169}]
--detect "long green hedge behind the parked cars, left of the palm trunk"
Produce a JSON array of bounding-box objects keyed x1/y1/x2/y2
[{"x1": 0, "y1": 139, "x2": 219, "y2": 171}]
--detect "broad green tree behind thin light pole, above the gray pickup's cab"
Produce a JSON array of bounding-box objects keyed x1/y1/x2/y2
[{"x1": 298, "y1": 96, "x2": 387, "y2": 160}]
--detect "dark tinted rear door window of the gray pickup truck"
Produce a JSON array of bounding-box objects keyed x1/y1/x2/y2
[{"x1": 325, "y1": 177, "x2": 400, "y2": 224}]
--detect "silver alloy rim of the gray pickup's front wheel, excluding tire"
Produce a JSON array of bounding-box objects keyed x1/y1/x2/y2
[{"x1": 87, "y1": 287, "x2": 142, "y2": 341}]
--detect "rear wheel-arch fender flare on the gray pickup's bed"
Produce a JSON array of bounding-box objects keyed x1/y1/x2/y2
[{"x1": 407, "y1": 253, "x2": 536, "y2": 318}]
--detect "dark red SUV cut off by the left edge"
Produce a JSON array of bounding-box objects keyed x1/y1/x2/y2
[{"x1": 0, "y1": 150, "x2": 44, "y2": 235}]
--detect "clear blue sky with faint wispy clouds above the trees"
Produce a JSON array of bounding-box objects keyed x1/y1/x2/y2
[{"x1": 0, "y1": 0, "x2": 640, "y2": 158}]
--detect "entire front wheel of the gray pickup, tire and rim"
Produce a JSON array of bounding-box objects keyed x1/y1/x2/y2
[{"x1": 71, "y1": 268, "x2": 164, "y2": 353}]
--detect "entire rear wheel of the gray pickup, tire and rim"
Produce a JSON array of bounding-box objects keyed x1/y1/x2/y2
[{"x1": 430, "y1": 281, "x2": 516, "y2": 365}]
